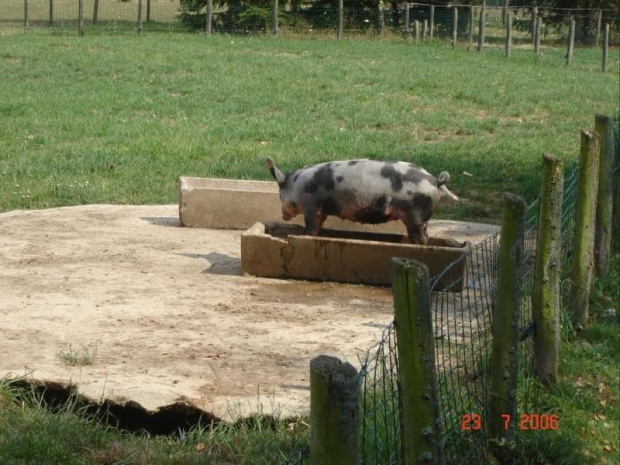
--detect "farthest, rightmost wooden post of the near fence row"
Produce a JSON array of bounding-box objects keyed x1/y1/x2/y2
[{"x1": 594, "y1": 115, "x2": 620, "y2": 278}]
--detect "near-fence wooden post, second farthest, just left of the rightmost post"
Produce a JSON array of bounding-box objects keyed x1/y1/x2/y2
[{"x1": 569, "y1": 130, "x2": 599, "y2": 327}]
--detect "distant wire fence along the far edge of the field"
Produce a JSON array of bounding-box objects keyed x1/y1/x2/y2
[{"x1": 0, "y1": 0, "x2": 620, "y2": 46}]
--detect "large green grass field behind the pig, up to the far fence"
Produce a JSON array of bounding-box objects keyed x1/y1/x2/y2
[{"x1": 0, "y1": 33, "x2": 620, "y2": 222}]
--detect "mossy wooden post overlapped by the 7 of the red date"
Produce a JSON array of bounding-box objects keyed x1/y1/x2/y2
[{"x1": 486, "y1": 194, "x2": 526, "y2": 462}]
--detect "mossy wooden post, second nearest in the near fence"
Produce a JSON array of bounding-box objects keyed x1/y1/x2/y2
[{"x1": 392, "y1": 258, "x2": 441, "y2": 465}]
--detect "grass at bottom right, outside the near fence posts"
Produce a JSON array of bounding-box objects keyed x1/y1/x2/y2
[{"x1": 515, "y1": 255, "x2": 620, "y2": 465}]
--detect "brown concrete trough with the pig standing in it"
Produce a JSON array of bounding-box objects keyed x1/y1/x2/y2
[{"x1": 241, "y1": 221, "x2": 470, "y2": 292}]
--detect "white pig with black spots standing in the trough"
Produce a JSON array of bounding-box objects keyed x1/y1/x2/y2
[{"x1": 265, "y1": 157, "x2": 458, "y2": 244}]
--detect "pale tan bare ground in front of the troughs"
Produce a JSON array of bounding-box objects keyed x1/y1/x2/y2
[{"x1": 0, "y1": 205, "x2": 496, "y2": 419}]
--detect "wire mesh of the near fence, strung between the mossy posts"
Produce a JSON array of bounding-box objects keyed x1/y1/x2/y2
[{"x1": 288, "y1": 154, "x2": 592, "y2": 465}]
